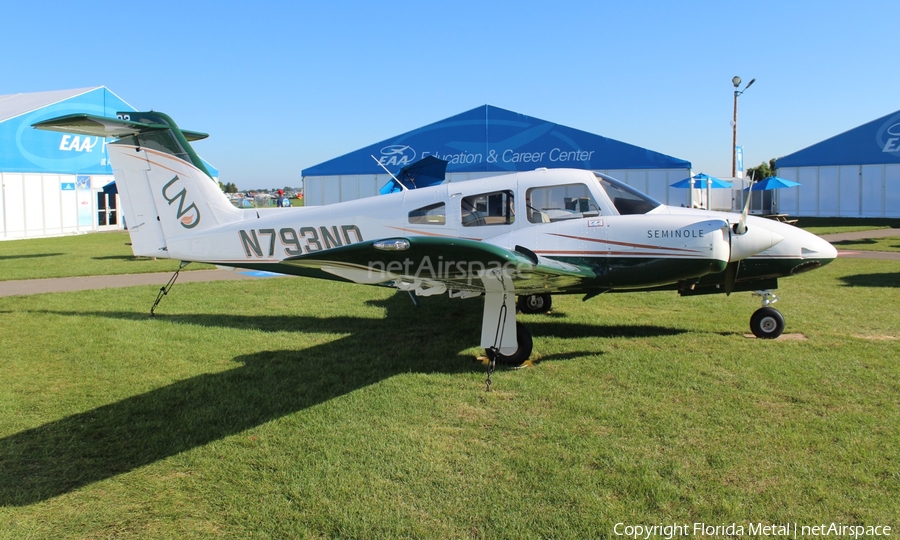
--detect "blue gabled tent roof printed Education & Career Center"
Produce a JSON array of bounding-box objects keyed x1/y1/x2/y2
[{"x1": 302, "y1": 105, "x2": 691, "y2": 177}]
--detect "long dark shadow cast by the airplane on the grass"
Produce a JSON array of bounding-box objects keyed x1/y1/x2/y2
[{"x1": 0, "y1": 295, "x2": 683, "y2": 506}]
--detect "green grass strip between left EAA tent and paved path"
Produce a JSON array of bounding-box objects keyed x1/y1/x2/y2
[{"x1": 0, "y1": 231, "x2": 213, "y2": 281}]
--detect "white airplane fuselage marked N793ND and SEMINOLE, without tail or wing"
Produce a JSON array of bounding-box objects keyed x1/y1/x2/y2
[{"x1": 153, "y1": 169, "x2": 835, "y2": 294}]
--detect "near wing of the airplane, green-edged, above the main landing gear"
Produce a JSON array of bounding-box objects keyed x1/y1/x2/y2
[{"x1": 282, "y1": 236, "x2": 597, "y2": 296}]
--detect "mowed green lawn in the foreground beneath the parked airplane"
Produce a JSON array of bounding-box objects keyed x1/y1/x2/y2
[{"x1": 0, "y1": 236, "x2": 900, "y2": 539}]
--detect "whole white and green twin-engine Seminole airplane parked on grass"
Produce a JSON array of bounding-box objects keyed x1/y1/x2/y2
[{"x1": 35, "y1": 112, "x2": 837, "y2": 365}]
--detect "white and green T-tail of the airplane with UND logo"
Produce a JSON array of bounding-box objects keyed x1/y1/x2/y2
[{"x1": 34, "y1": 112, "x2": 243, "y2": 258}]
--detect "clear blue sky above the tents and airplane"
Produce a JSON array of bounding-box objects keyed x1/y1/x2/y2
[{"x1": 0, "y1": 0, "x2": 900, "y2": 189}]
